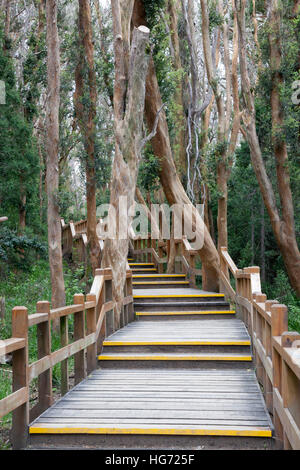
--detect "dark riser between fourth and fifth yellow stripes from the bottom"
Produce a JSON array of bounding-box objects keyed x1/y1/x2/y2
[{"x1": 134, "y1": 299, "x2": 231, "y2": 312}]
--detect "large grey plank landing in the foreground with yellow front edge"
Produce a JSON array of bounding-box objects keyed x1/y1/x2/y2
[{"x1": 30, "y1": 369, "x2": 272, "y2": 437}]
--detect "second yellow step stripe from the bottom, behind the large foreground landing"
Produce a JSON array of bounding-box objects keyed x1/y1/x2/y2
[{"x1": 98, "y1": 355, "x2": 252, "y2": 361}]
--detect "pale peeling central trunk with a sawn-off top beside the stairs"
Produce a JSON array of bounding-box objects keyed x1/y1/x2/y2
[{"x1": 102, "y1": 0, "x2": 150, "y2": 327}]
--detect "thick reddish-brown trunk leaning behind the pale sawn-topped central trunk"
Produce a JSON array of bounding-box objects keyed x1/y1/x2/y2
[{"x1": 133, "y1": 0, "x2": 220, "y2": 291}]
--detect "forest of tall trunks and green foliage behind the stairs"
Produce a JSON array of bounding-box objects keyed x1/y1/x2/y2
[{"x1": 0, "y1": 0, "x2": 300, "y2": 312}]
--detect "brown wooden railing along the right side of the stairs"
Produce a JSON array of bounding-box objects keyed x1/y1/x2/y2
[{"x1": 221, "y1": 244, "x2": 300, "y2": 450}]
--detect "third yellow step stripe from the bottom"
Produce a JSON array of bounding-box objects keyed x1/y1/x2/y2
[{"x1": 103, "y1": 340, "x2": 251, "y2": 346}]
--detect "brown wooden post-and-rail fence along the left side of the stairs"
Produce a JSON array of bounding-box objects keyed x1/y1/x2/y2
[{"x1": 0, "y1": 269, "x2": 134, "y2": 449}]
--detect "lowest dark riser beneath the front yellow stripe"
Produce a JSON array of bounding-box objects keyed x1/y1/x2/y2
[{"x1": 30, "y1": 434, "x2": 275, "y2": 450}]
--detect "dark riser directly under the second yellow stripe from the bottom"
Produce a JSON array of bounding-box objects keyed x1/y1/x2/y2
[{"x1": 99, "y1": 360, "x2": 253, "y2": 369}]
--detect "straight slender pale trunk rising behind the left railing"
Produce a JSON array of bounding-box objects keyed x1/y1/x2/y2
[{"x1": 46, "y1": 0, "x2": 66, "y2": 308}]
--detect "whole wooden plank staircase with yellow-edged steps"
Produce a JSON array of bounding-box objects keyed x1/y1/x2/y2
[{"x1": 30, "y1": 260, "x2": 274, "y2": 449}]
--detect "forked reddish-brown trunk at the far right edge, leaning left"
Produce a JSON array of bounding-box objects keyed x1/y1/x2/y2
[{"x1": 235, "y1": 0, "x2": 300, "y2": 296}]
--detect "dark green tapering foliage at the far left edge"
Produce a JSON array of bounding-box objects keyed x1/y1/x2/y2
[{"x1": 0, "y1": 30, "x2": 39, "y2": 227}]
